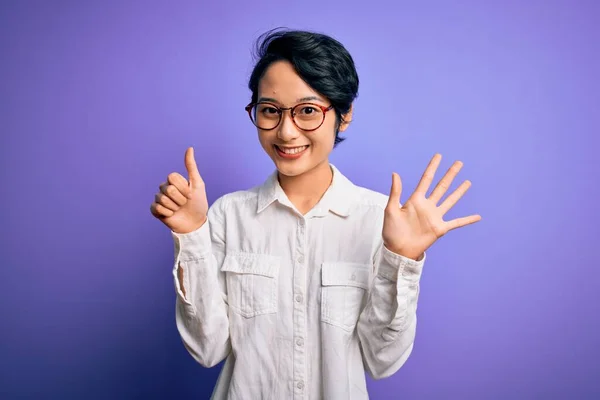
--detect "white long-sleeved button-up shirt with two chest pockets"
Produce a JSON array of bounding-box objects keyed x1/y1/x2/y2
[{"x1": 172, "y1": 165, "x2": 425, "y2": 400}]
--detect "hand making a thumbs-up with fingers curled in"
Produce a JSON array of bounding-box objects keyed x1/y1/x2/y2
[{"x1": 150, "y1": 147, "x2": 208, "y2": 233}]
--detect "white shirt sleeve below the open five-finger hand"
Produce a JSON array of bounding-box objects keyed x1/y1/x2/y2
[{"x1": 357, "y1": 244, "x2": 426, "y2": 379}]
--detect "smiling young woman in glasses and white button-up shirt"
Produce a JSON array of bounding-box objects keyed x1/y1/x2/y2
[{"x1": 151, "y1": 31, "x2": 480, "y2": 399}]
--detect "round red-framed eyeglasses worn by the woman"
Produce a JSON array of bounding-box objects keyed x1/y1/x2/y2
[{"x1": 245, "y1": 102, "x2": 333, "y2": 131}]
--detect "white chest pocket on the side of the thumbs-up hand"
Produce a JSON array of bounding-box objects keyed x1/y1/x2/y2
[{"x1": 221, "y1": 253, "x2": 279, "y2": 318}]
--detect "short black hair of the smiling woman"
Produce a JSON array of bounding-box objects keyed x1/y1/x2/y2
[{"x1": 248, "y1": 28, "x2": 358, "y2": 147}]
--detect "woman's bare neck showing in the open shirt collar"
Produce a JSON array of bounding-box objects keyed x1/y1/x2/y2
[{"x1": 278, "y1": 161, "x2": 333, "y2": 213}]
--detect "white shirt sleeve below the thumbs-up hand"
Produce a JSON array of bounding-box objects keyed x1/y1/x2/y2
[{"x1": 172, "y1": 199, "x2": 231, "y2": 367}]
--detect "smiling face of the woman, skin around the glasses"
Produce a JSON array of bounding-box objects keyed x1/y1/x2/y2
[{"x1": 257, "y1": 61, "x2": 350, "y2": 176}]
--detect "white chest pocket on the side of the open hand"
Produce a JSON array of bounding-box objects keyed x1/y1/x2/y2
[{"x1": 321, "y1": 262, "x2": 372, "y2": 332}]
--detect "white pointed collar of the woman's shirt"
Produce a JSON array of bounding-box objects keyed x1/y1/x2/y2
[{"x1": 257, "y1": 164, "x2": 356, "y2": 217}]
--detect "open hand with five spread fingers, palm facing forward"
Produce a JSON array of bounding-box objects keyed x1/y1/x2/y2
[{"x1": 382, "y1": 154, "x2": 481, "y2": 260}]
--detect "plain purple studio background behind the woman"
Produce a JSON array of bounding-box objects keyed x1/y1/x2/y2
[{"x1": 0, "y1": 0, "x2": 600, "y2": 399}]
